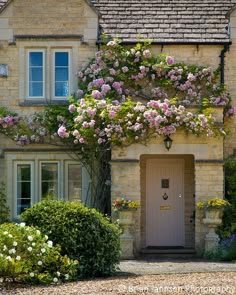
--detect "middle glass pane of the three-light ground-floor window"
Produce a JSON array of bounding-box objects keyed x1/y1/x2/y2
[{"x1": 41, "y1": 163, "x2": 58, "y2": 199}]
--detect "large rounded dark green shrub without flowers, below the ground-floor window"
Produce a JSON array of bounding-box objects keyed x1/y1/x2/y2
[{"x1": 21, "y1": 200, "x2": 120, "y2": 277}]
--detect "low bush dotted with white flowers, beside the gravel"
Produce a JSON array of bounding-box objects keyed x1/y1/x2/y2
[{"x1": 0, "y1": 223, "x2": 78, "y2": 284}]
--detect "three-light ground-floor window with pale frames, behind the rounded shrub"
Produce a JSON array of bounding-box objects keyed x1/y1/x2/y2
[{"x1": 9, "y1": 157, "x2": 86, "y2": 217}]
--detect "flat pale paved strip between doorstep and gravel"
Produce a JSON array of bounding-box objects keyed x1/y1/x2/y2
[{"x1": 119, "y1": 259, "x2": 236, "y2": 275}]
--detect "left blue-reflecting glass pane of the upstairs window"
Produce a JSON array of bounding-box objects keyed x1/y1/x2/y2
[{"x1": 28, "y1": 51, "x2": 45, "y2": 98}]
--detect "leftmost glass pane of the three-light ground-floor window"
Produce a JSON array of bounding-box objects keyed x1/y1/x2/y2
[{"x1": 16, "y1": 164, "x2": 31, "y2": 215}]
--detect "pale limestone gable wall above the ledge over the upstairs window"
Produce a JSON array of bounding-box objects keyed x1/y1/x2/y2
[{"x1": 0, "y1": 0, "x2": 98, "y2": 41}]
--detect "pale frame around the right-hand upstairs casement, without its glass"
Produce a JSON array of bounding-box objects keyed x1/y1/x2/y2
[{"x1": 50, "y1": 48, "x2": 72, "y2": 100}]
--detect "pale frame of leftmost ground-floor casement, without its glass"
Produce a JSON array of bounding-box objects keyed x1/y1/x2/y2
[{"x1": 13, "y1": 161, "x2": 35, "y2": 217}]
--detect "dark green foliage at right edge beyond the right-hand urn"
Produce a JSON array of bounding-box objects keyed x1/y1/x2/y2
[{"x1": 217, "y1": 157, "x2": 236, "y2": 238}]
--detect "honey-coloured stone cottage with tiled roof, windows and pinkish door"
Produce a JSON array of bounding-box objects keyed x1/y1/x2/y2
[{"x1": 0, "y1": 0, "x2": 236, "y2": 254}]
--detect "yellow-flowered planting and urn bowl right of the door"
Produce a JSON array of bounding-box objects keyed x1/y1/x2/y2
[{"x1": 197, "y1": 198, "x2": 230, "y2": 219}]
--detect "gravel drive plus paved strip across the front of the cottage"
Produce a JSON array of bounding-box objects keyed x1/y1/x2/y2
[{"x1": 0, "y1": 260, "x2": 236, "y2": 295}]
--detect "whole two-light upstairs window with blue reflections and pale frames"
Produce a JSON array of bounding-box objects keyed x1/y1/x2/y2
[{"x1": 26, "y1": 49, "x2": 71, "y2": 100}]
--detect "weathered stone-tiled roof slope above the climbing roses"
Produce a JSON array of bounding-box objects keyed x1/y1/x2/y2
[{"x1": 92, "y1": 0, "x2": 236, "y2": 44}]
